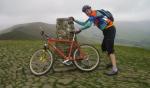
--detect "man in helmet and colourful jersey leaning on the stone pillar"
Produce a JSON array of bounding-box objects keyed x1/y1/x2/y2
[{"x1": 70, "y1": 5, "x2": 118, "y2": 76}]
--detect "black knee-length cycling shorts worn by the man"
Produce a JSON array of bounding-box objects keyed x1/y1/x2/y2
[{"x1": 101, "y1": 26, "x2": 116, "y2": 54}]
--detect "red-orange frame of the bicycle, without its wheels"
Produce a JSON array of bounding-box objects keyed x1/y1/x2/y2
[{"x1": 47, "y1": 33, "x2": 84, "y2": 60}]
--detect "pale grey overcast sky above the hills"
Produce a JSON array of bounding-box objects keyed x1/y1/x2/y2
[{"x1": 0, "y1": 0, "x2": 150, "y2": 29}]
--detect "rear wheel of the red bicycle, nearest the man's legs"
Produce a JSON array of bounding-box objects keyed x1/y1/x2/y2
[{"x1": 74, "y1": 44, "x2": 100, "y2": 71}]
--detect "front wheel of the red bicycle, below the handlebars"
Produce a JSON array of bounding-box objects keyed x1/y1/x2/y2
[{"x1": 30, "y1": 49, "x2": 53, "y2": 75}]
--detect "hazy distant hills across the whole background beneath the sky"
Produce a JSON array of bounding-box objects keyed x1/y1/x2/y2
[{"x1": 0, "y1": 21, "x2": 150, "y2": 48}]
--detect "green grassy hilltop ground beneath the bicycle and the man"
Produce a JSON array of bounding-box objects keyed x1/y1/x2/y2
[{"x1": 0, "y1": 40, "x2": 150, "y2": 88}]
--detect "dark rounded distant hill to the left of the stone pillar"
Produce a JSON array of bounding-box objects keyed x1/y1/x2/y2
[{"x1": 0, "y1": 22, "x2": 56, "y2": 40}]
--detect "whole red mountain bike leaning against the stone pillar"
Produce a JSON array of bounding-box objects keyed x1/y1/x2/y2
[{"x1": 30, "y1": 31, "x2": 100, "y2": 75}]
